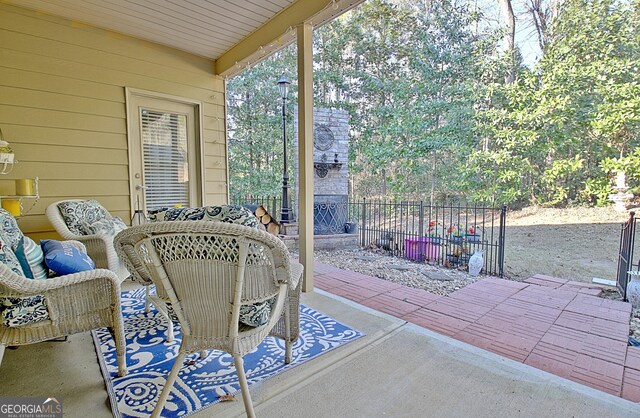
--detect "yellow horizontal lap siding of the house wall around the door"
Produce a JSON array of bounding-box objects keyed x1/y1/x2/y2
[{"x1": 0, "y1": 3, "x2": 227, "y2": 238}]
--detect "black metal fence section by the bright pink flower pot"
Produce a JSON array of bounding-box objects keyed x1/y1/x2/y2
[{"x1": 349, "y1": 199, "x2": 507, "y2": 276}]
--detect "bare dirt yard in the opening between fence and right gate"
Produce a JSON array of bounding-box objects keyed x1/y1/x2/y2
[{"x1": 505, "y1": 207, "x2": 629, "y2": 282}]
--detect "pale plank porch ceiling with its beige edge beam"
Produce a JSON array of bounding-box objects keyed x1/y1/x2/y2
[{"x1": 7, "y1": 0, "x2": 362, "y2": 74}]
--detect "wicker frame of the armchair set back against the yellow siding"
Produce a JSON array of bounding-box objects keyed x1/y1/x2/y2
[{"x1": 46, "y1": 199, "x2": 129, "y2": 281}]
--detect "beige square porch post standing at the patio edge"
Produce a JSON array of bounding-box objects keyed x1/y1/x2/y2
[{"x1": 297, "y1": 23, "x2": 313, "y2": 292}]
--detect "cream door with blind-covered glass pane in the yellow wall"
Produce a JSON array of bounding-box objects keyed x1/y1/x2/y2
[{"x1": 129, "y1": 94, "x2": 202, "y2": 211}]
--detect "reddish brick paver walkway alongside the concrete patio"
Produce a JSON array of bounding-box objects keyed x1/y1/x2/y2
[{"x1": 314, "y1": 263, "x2": 640, "y2": 402}]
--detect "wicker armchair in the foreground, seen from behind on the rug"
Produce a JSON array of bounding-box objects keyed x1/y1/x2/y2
[{"x1": 115, "y1": 221, "x2": 302, "y2": 417}]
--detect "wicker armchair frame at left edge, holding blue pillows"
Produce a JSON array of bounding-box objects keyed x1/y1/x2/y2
[{"x1": 0, "y1": 263, "x2": 127, "y2": 376}]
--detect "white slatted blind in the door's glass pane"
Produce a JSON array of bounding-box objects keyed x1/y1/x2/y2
[{"x1": 140, "y1": 109, "x2": 190, "y2": 210}]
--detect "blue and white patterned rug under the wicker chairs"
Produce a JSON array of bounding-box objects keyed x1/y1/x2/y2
[{"x1": 92, "y1": 289, "x2": 363, "y2": 417}]
